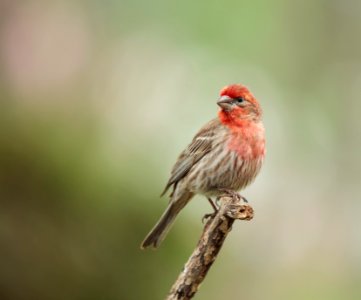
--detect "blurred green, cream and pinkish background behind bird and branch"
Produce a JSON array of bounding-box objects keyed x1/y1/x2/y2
[{"x1": 0, "y1": 0, "x2": 361, "y2": 300}]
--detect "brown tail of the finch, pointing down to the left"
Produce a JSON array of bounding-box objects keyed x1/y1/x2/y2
[{"x1": 140, "y1": 194, "x2": 193, "y2": 249}]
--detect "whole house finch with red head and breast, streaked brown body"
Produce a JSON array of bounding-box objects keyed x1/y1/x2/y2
[{"x1": 141, "y1": 84, "x2": 265, "y2": 249}]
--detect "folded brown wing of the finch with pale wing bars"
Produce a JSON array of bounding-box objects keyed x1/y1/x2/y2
[{"x1": 162, "y1": 119, "x2": 220, "y2": 196}]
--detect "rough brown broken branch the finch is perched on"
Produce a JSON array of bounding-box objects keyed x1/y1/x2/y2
[{"x1": 166, "y1": 194, "x2": 253, "y2": 300}]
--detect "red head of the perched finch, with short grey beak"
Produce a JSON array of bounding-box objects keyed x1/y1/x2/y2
[{"x1": 217, "y1": 84, "x2": 262, "y2": 121}]
